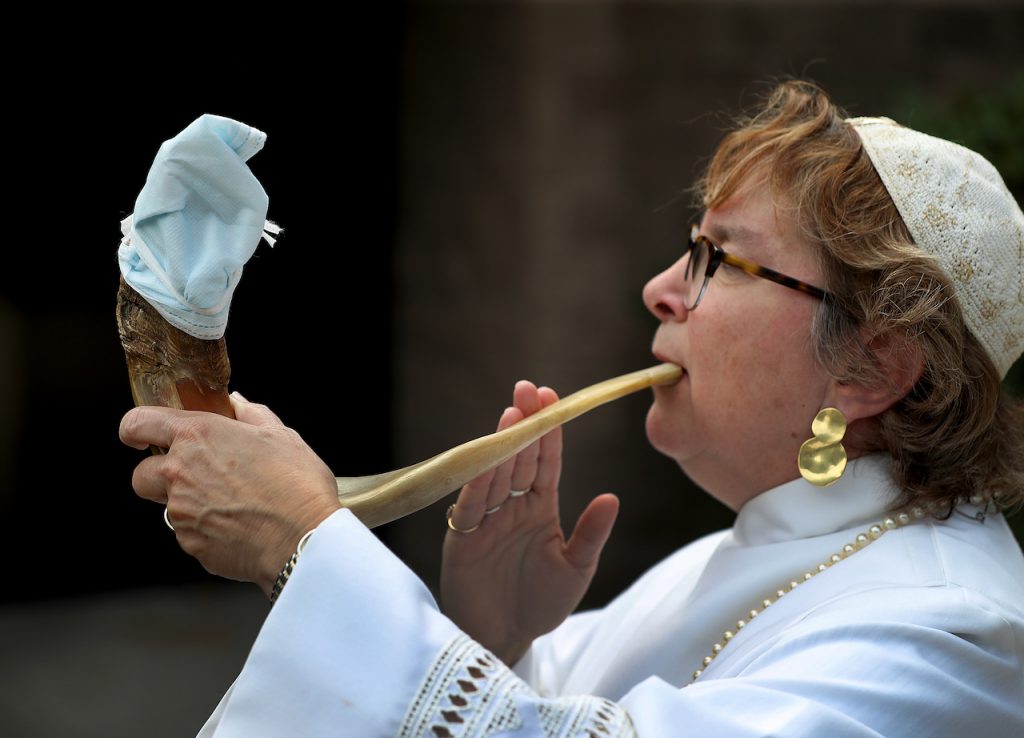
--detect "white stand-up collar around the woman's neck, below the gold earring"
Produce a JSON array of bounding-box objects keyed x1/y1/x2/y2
[{"x1": 732, "y1": 453, "x2": 897, "y2": 547}]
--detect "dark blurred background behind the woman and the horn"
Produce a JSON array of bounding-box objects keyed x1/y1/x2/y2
[{"x1": 0, "y1": 2, "x2": 1024, "y2": 736}]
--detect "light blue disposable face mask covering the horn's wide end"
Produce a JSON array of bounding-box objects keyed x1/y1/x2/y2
[{"x1": 118, "y1": 115, "x2": 280, "y2": 339}]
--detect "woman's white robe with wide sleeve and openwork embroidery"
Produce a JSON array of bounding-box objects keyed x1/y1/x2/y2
[{"x1": 200, "y1": 457, "x2": 1024, "y2": 738}]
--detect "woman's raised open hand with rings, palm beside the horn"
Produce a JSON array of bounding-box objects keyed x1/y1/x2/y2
[{"x1": 441, "y1": 382, "x2": 618, "y2": 664}]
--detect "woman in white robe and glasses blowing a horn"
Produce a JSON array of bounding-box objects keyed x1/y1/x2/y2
[{"x1": 122, "y1": 83, "x2": 1024, "y2": 737}]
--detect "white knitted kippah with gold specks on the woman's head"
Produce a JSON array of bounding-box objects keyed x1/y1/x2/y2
[{"x1": 847, "y1": 118, "x2": 1024, "y2": 377}]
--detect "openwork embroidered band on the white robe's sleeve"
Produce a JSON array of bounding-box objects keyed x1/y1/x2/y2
[{"x1": 397, "y1": 634, "x2": 636, "y2": 738}]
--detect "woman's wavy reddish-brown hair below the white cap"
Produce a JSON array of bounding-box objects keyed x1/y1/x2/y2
[{"x1": 695, "y1": 81, "x2": 1024, "y2": 515}]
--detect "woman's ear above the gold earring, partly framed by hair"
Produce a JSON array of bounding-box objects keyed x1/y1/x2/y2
[{"x1": 824, "y1": 332, "x2": 925, "y2": 423}]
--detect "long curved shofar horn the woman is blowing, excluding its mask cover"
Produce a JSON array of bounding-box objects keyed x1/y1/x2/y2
[{"x1": 117, "y1": 279, "x2": 682, "y2": 528}]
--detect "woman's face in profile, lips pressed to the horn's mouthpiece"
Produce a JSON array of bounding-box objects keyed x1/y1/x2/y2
[{"x1": 643, "y1": 181, "x2": 828, "y2": 510}]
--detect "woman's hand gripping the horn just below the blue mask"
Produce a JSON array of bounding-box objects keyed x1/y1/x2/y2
[{"x1": 120, "y1": 393, "x2": 341, "y2": 595}]
